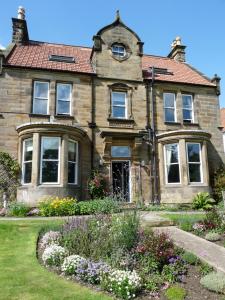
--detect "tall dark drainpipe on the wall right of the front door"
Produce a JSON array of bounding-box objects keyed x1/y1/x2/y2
[{"x1": 150, "y1": 67, "x2": 159, "y2": 204}]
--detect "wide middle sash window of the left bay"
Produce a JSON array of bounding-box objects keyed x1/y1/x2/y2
[{"x1": 40, "y1": 137, "x2": 61, "y2": 183}]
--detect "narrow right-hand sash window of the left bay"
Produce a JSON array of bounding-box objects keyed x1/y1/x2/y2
[{"x1": 68, "y1": 140, "x2": 78, "y2": 184}]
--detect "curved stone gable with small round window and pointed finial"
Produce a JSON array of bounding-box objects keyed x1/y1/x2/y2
[{"x1": 91, "y1": 11, "x2": 143, "y2": 80}]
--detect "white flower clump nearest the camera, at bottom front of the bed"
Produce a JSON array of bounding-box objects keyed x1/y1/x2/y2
[{"x1": 101, "y1": 270, "x2": 141, "y2": 299}]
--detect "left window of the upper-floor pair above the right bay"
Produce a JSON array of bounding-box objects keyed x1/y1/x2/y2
[{"x1": 163, "y1": 93, "x2": 176, "y2": 122}]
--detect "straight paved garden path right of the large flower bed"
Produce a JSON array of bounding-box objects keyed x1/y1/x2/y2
[{"x1": 154, "y1": 226, "x2": 225, "y2": 273}]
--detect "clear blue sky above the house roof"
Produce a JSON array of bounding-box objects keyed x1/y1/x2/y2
[{"x1": 0, "y1": 0, "x2": 225, "y2": 107}]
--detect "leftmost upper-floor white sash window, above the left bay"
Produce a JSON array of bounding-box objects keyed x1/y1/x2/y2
[{"x1": 33, "y1": 81, "x2": 49, "y2": 114}]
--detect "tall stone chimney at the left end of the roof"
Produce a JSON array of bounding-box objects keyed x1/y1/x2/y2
[{"x1": 12, "y1": 6, "x2": 29, "y2": 44}]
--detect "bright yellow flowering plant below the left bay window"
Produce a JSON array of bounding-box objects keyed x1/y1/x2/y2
[{"x1": 38, "y1": 196, "x2": 78, "y2": 217}]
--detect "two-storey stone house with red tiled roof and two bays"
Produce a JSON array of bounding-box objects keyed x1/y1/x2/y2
[{"x1": 0, "y1": 7, "x2": 224, "y2": 205}]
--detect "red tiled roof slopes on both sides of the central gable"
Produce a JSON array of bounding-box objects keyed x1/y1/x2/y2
[{"x1": 6, "y1": 41, "x2": 215, "y2": 86}]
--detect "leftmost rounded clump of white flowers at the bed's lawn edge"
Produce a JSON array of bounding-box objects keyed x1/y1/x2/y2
[{"x1": 42, "y1": 244, "x2": 67, "y2": 266}]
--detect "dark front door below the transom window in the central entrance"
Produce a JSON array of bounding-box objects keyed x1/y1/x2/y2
[{"x1": 112, "y1": 161, "x2": 130, "y2": 202}]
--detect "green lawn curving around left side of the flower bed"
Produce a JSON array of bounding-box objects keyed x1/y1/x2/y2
[{"x1": 0, "y1": 220, "x2": 111, "y2": 300}]
